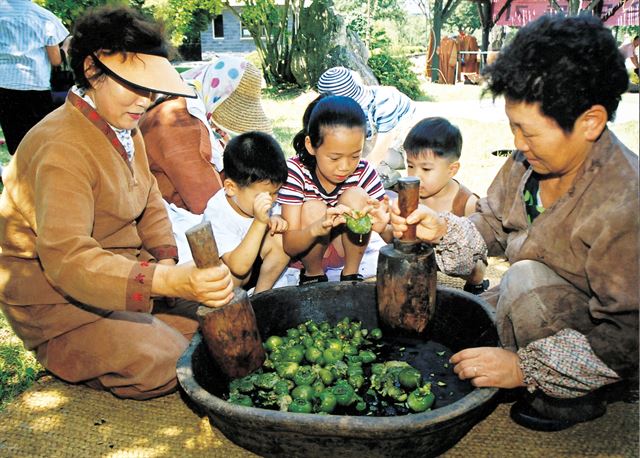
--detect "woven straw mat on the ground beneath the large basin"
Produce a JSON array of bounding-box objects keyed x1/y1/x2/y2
[{"x1": 0, "y1": 377, "x2": 638, "y2": 458}]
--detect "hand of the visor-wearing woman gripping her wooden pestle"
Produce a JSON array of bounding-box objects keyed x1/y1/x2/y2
[{"x1": 176, "y1": 262, "x2": 233, "y2": 307}]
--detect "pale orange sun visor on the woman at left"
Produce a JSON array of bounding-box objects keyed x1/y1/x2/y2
[{"x1": 92, "y1": 52, "x2": 196, "y2": 98}]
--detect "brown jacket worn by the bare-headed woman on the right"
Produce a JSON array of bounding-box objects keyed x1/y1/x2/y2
[{"x1": 469, "y1": 130, "x2": 640, "y2": 377}]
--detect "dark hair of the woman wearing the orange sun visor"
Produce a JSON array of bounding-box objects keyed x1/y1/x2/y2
[{"x1": 69, "y1": 6, "x2": 172, "y2": 88}]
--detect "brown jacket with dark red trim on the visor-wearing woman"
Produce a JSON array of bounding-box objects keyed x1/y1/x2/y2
[{"x1": 0, "y1": 94, "x2": 177, "y2": 348}]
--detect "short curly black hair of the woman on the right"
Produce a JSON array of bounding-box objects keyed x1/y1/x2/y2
[{"x1": 483, "y1": 15, "x2": 629, "y2": 132}]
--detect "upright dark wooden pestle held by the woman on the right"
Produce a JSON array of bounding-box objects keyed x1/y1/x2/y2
[{"x1": 376, "y1": 177, "x2": 437, "y2": 332}]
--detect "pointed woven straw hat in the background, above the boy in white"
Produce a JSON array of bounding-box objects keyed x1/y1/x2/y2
[{"x1": 211, "y1": 62, "x2": 272, "y2": 133}]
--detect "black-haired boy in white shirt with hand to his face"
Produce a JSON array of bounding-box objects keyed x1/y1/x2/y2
[{"x1": 203, "y1": 132, "x2": 289, "y2": 293}]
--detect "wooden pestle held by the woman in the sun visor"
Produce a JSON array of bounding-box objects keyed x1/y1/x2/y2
[{"x1": 186, "y1": 222, "x2": 265, "y2": 379}]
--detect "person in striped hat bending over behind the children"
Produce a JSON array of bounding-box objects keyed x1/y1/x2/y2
[{"x1": 318, "y1": 67, "x2": 415, "y2": 189}]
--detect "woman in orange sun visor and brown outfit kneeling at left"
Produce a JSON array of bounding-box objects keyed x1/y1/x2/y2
[{"x1": 0, "y1": 7, "x2": 233, "y2": 399}]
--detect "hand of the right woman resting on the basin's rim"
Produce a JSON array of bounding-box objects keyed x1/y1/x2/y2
[{"x1": 449, "y1": 347, "x2": 525, "y2": 388}]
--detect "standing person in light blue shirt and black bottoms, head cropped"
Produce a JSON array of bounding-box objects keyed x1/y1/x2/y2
[{"x1": 0, "y1": 0, "x2": 69, "y2": 155}]
